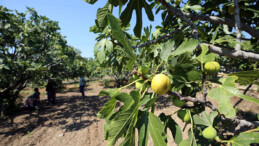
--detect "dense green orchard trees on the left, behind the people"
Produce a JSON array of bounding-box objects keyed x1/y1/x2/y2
[{"x1": 0, "y1": 6, "x2": 100, "y2": 115}]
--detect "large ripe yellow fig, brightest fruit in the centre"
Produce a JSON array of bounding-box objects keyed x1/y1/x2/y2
[{"x1": 151, "y1": 74, "x2": 171, "y2": 95}]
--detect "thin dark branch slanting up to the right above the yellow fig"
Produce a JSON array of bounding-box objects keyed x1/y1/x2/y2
[{"x1": 132, "y1": 25, "x2": 188, "y2": 48}]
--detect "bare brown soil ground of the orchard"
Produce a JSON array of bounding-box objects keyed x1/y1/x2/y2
[{"x1": 0, "y1": 78, "x2": 259, "y2": 146}]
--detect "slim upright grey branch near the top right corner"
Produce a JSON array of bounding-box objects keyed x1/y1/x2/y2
[{"x1": 233, "y1": 0, "x2": 241, "y2": 51}]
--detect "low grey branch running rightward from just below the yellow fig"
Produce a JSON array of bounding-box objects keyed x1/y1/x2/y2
[{"x1": 168, "y1": 91, "x2": 259, "y2": 127}]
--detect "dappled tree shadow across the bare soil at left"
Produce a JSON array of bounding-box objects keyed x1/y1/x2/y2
[{"x1": 0, "y1": 96, "x2": 109, "y2": 136}]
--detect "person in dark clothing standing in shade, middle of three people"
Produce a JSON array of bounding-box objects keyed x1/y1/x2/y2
[{"x1": 46, "y1": 79, "x2": 57, "y2": 104}]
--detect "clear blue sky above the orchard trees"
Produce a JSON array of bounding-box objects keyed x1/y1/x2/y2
[{"x1": 0, "y1": 0, "x2": 161, "y2": 58}]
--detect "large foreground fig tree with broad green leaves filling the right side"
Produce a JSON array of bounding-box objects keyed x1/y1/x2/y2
[{"x1": 84, "y1": 0, "x2": 259, "y2": 146}]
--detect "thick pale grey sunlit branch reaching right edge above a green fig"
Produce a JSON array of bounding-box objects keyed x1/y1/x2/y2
[{"x1": 201, "y1": 43, "x2": 259, "y2": 62}]
